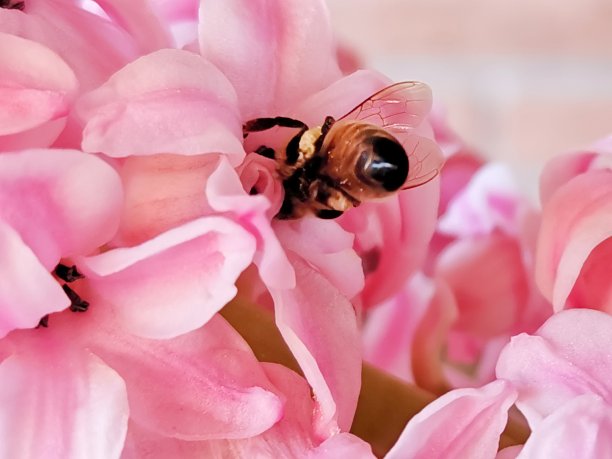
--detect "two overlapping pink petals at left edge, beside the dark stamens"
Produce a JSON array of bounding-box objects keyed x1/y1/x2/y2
[{"x1": 0, "y1": 150, "x2": 122, "y2": 336}]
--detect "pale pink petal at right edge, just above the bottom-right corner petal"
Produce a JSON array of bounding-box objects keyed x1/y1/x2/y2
[{"x1": 496, "y1": 309, "x2": 612, "y2": 427}]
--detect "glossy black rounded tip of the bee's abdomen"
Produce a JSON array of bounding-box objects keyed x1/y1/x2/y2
[{"x1": 357, "y1": 136, "x2": 408, "y2": 191}]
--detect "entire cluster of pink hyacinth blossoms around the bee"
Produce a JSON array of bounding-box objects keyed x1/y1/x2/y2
[{"x1": 0, "y1": 0, "x2": 612, "y2": 458}]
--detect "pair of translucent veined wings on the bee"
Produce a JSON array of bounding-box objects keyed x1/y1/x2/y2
[{"x1": 340, "y1": 81, "x2": 444, "y2": 189}]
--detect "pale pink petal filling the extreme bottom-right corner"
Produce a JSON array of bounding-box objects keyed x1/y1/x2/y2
[{"x1": 517, "y1": 395, "x2": 612, "y2": 459}]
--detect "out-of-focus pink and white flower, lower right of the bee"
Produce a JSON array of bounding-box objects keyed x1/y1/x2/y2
[{"x1": 364, "y1": 164, "x2": 552, "y2": 393}]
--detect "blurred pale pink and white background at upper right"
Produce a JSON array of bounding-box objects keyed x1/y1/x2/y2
[{"x1": 328, "y1": 0, "x2": 612, "y2": 201}]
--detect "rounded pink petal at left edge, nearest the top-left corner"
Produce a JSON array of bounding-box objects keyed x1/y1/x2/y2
[{"x1": 0, "y1": 33, "x2": 78, "y2": 143}]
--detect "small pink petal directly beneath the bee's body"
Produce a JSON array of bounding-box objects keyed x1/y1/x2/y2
[{"x1": 274, "y1": 218, "x2": 364, "y2": 298}]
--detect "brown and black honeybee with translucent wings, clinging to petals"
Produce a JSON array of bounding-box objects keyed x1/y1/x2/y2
[{"x1": 243, "y1": 81, "x2": 444, "y2": 219}]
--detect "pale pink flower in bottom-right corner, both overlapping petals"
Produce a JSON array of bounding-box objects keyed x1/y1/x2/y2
[{"x1": 497, "y1": 309, "x2": 612, "y2": 458}]
